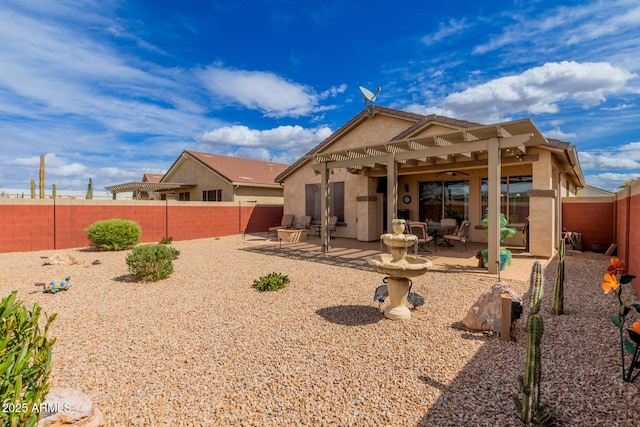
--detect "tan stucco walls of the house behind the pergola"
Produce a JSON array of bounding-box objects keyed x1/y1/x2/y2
[{"x1": 285, "y1": 116, "x2": 575, "y2": 257}]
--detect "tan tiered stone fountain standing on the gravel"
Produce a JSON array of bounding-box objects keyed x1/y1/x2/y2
[{"x1": 368, "y1": 219, "x2": 431, "y2": 320}]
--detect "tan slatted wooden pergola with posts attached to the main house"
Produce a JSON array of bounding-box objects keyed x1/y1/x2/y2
[{"x1": 307, "y1": 119, "x2": 548, "y2": 273}]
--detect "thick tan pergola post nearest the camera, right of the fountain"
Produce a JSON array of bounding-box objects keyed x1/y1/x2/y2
[{"x1": 487, "y1": 138, "x2": 502, "y2": 274}]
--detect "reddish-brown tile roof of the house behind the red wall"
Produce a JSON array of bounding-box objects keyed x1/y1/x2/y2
[{"x1": 184, "y1": 150, "x2": 289, "y2": 185}]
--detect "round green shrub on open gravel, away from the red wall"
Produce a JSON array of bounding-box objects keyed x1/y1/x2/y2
[{"x1": 126, "y1": 244, "x2": 175, "y2": 282}]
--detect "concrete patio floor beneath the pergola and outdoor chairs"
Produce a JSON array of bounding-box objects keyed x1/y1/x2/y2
[{"x1": 244, "y1": 233, "x2": 550, "y2": 281}]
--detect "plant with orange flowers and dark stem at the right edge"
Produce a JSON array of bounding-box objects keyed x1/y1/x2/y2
[{"x1": 602, "y1": 258, "x2": 640, "y2": 382}]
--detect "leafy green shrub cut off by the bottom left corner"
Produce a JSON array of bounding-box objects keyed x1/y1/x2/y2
[{"x1": 0, "y1": 292, "x2": 56, "y2": 426}]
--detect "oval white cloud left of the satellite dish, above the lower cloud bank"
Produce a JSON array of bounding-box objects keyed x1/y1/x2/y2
[{"x1": 197, "y1": 66, "x2": 318, "y2": 117}]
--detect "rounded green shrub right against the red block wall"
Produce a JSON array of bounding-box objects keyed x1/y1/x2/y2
[{"x1": 84, "y1": 219, "x2": 141, "y2": 251}]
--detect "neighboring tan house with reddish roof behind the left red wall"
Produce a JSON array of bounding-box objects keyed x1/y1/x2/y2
[{"x1": 106, "y1": 150, "x2": 288, "y2": 205}]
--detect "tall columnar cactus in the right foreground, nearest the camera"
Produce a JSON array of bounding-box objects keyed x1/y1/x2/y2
[{"x1": 514, "y1": 261, "x2": 551, "y2": 425}]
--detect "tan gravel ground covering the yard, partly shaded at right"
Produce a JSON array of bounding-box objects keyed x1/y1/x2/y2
[{"x1": 0, "y1": 236, "x2": 640, "y2": 426}]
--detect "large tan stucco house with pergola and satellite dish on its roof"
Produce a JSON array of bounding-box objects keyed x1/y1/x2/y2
[{"x1": 276, "y1": 106, "x2": 585, "y2": 271}]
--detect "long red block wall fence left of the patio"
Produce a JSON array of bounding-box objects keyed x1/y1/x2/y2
[{"x1": 0, "y1": 199, "x2": 283, "y2": 253}]
